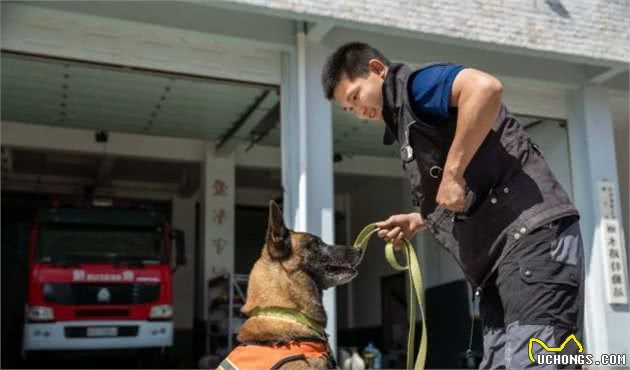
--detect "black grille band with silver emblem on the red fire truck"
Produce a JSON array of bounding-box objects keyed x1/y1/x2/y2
[{"x1": 43, "y1": 283, "x2": 160, "y2": 305}]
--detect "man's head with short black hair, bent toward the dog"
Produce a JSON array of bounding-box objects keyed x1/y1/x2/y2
[{"x1": 322, "y1": 42, "x2": 390, "y2": 120}]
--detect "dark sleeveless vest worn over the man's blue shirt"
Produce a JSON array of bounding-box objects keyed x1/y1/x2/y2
[{"x1": 383, "y1": 64, "x2": 577, "y2": 286}]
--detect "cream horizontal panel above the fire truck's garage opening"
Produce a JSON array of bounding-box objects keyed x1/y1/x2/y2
[{"x1": 2, "y1": 2, "x2": 280, "y2": 84}]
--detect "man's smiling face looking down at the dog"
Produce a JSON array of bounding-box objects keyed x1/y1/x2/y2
[{"x1": 333, "y1": 59, "x2": 387, "y2": 120}]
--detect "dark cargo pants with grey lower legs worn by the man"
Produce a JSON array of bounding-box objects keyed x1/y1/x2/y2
[{"x1": 479, "y1": 217, "x2": 584, "y2": 369}]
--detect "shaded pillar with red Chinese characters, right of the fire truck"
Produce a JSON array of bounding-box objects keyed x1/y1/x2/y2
[{"x1": 200, "y1": 142, "x2": 236, "y2": 320}]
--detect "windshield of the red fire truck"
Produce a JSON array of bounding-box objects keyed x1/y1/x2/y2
[{"x1": 35, "y1": 223, "x2": 166, "y2": 264}]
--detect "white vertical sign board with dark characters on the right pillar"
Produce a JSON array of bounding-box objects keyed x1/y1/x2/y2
[{"x1": 598, "y1": 180, "x2": 628, "y2": 304}]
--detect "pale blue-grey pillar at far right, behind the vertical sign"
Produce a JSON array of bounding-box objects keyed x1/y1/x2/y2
[{"x1": 569, "y1": 86, "x2": 630, "y2": 359}]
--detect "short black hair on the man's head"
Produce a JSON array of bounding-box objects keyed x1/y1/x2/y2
[{"x1": 322, "y1": 42, "x2": 391, "y2": 100}]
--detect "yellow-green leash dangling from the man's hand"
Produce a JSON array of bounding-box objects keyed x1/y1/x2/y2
[{"x1": 354, "y1": 224, "x2": 427, "y2": 370}]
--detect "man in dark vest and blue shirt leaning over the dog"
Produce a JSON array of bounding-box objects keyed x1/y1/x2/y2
[{"x1": 322, "y1": 42, "x2": 584, "y2": 369}]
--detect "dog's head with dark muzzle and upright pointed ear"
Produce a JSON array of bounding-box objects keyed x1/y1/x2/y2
[{"x1": 263, "y1": 201, "x2": 361, "y2": 289}]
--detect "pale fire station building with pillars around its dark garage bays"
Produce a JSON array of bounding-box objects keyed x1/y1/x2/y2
[{"x1": 2, "y1": 0, "x2": 630, "y2": 364}]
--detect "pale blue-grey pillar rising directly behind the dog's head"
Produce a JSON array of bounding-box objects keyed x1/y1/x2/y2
[{"x1": 281, "y1": 26, "x2": 337, "y2": 349}]
